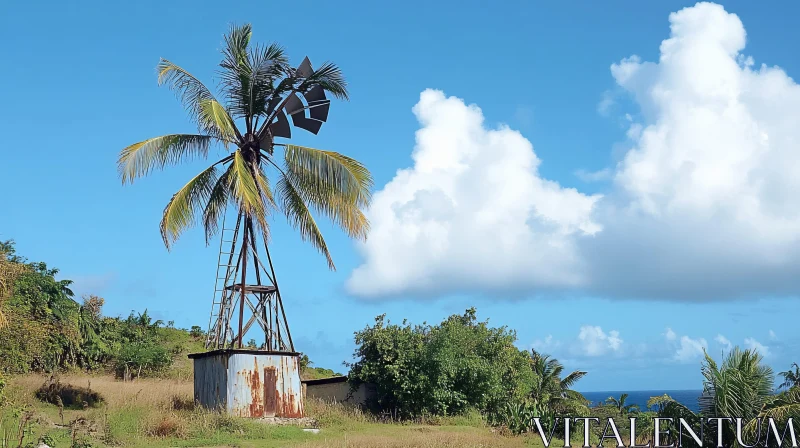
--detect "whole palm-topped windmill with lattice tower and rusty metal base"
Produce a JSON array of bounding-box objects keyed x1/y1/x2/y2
[{"x1": 118, "y1": 25, "x2": 372, "y2": 418}]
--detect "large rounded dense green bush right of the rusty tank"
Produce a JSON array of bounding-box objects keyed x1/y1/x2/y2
[{"x1": 350, "y1": 308, "x2": 533, "y2": 418}]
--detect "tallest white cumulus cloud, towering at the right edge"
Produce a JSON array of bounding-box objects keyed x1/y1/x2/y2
[{"x1": 587, "y1": 3, "x2": 800, "y2": 299}]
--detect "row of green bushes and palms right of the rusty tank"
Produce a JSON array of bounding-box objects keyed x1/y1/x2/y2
[{"x1": 349, "y1": 308, "x2": 800, "y2": 446}]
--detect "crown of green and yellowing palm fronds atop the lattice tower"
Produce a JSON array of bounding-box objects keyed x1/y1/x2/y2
[{"x1": 118, "y1": 25, "x2": 372, "y2": 269}]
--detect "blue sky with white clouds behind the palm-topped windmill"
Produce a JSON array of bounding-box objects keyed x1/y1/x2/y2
[{"x1": 0, "y1": 1, "x2": 800, "y2": 390}]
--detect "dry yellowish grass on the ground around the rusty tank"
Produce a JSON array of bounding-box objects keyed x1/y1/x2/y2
[{"x1": 1, "y1": 375, "x2": 541, "y2": 448}]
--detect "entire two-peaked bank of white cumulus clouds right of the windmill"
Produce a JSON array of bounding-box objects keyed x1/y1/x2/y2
[{"x1": 347, "y1": 3, "x2": 800, "y2": 300}]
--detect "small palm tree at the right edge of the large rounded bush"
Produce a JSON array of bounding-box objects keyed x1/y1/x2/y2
[{"x1": 531, "y1": 350, "x2": 587, "y2": 411}]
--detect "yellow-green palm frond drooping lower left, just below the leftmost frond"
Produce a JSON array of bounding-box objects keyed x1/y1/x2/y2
[{"x1": 161, "y1": 164, "x2": 222, "y2": 249}]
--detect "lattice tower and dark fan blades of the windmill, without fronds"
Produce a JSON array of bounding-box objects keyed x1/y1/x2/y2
[{"x1": 206, "y1": 58, "x2": 330, "y2": 352}]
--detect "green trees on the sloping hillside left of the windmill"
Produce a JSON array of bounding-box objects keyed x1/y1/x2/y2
[{"x1": 0, "y1": 241, "x2": 191, "y2": 379}]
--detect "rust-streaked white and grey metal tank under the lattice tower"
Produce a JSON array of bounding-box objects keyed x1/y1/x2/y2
[{"x1": 189, "y1": 350, "x2": 303, "y2": 418}]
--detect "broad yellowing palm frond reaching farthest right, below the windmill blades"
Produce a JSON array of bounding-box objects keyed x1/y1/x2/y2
[{"x1": 284, "y1": 145, "x2": 372, "y2": 239}]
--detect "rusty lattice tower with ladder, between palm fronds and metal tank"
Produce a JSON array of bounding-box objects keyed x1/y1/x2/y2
[{"x1": 206, "y1": 213, "x2": 294, "y2": 352}]
